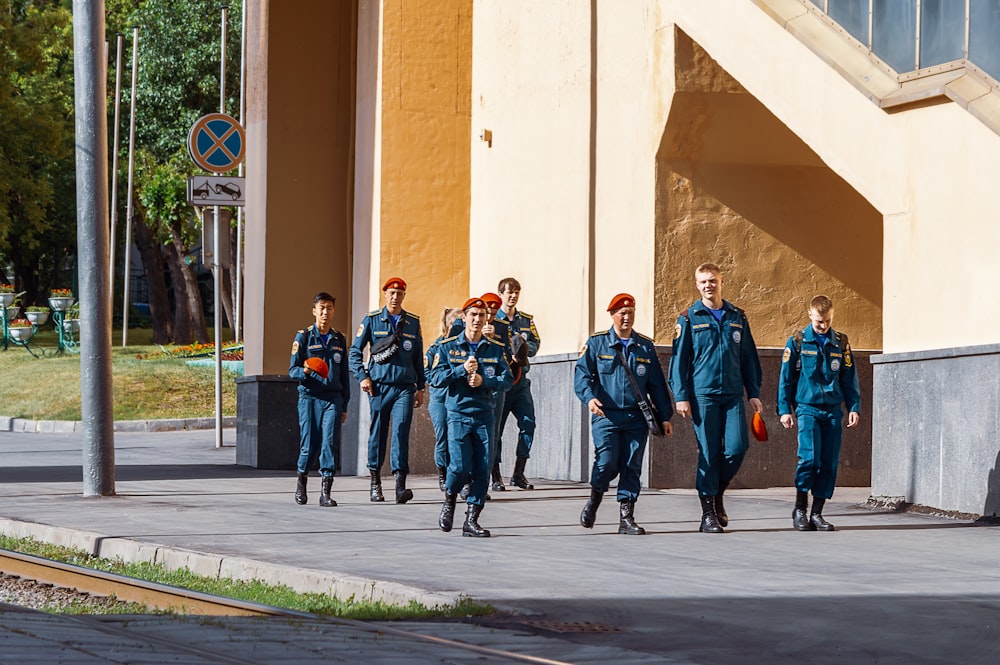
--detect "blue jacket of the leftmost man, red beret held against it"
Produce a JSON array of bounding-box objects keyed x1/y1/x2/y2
[{"x1": 288, "y1": 325, "x2": 351, "y2": 409}]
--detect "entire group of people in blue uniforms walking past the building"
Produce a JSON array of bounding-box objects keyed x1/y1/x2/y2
[{"x1": 289, "y1": 263, "x2": 860, "y2": 537}]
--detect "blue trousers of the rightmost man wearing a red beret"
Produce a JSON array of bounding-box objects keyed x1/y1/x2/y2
[{"x1": 590, "y1": 409, "x2": 649, "y2": 502}]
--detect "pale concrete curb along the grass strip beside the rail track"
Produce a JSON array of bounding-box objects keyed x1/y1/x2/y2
[{"x1": 0, "y1": 518, "x2": 466, "y2": 608}]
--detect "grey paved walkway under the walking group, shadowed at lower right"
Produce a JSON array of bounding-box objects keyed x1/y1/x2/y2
[{"x1": 0, "y1": 430, "x2": 1000, "y2": 665}]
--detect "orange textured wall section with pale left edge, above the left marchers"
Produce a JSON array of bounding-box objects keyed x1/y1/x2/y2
[{"x1": 354, "y1": 0, "x2": 472, "y2": 332}]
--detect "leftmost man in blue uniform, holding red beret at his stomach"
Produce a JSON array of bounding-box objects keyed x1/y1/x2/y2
[{"x1": 288, "y1": 291, "x2": 351, "y2": 506}]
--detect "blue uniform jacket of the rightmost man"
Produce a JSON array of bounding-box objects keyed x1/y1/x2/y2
[{"x1": 777, "y1": 325, "x2": 861, "y2": 416}]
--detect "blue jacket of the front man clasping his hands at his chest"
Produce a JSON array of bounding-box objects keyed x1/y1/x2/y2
[{"x1": 429, "y1": 332, "x2": 514, "y2": 420}]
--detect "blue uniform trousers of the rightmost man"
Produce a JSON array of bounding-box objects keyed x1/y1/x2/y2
[{"x1": 795, "y1": 405, "x2": 844, "y2": 499}]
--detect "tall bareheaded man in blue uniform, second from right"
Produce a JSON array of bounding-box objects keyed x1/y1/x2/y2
[{"x1": 670, "y1": 263, "x2": 761, "y2": 533}]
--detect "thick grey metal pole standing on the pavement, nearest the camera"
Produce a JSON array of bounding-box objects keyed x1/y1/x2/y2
[{"x1": 73, "y1": 0, "x2": 115, "y2": 496}]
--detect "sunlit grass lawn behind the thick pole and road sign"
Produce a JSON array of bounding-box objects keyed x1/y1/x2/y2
[{"x1": 0, "y1": 324, "x2": 236, "y2": 420}]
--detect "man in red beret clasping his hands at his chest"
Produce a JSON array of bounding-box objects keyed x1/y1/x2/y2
[{"x1": 430, "y1": 298, "x2": 511, "y2": 538}]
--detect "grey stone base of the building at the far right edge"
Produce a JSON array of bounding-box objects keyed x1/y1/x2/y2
[{"x1": 871, "y1": 344, "x2": 1000, "y2": 517}]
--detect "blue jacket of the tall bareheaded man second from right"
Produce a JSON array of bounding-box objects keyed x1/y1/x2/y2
[{"x1": 670, "y1": 300, "x2": 761, "y2": 402}]
